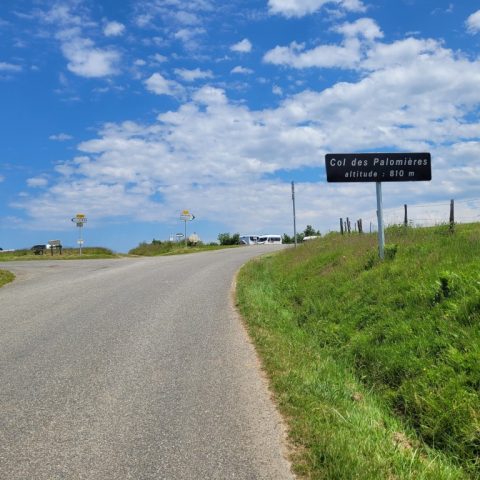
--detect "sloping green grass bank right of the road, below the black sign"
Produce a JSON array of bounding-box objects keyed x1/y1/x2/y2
[{"x1": 237, "y1": 224, "x2": 480, "y2": 479}]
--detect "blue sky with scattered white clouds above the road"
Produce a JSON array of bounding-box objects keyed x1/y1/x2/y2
[{"x1": 0, "y1": 0, "x2": 480, "y2": 251}]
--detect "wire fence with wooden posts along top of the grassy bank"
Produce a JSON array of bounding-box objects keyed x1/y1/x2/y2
[{"x1": 340, "y1": 198, "x2": 480, "y2": 233}]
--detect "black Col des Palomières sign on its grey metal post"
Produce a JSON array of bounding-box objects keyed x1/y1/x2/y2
[{"x1": 325, "y1": 152, "x2": 432, "y2": 260}]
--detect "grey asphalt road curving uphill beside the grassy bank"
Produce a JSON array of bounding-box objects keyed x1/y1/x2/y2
[{"x1": 0, "y1": 246, "x2": 293, "y2": 480}]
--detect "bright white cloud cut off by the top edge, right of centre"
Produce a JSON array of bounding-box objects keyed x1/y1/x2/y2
[{"x1": 268, "y1": 0, "x2": 366, "y2": 17}]
